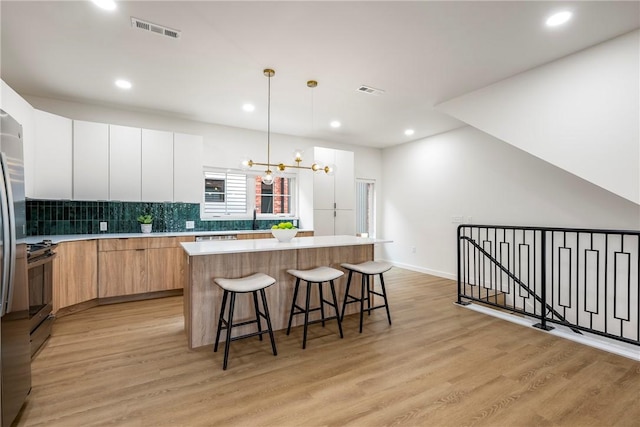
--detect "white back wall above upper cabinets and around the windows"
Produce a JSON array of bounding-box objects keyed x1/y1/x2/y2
[{"x1": 25, "y1": 95, "x2": 382, "y2": 232}]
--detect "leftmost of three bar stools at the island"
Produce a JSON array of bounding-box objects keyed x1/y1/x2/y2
[{"x1": 213, "y1": 273, "x2": 278, "y2": 370}]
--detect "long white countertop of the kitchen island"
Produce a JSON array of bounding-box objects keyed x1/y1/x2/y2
[{"x1": 181, "y1": 236, "x2": 392, "y2": 256}]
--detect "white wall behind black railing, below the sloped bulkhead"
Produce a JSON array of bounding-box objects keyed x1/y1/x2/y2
[{"x1": 382, "y1": 127, "x2": 640, "y2": 279}]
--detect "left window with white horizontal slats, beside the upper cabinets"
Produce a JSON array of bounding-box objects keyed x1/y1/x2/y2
[{"x1": 202, "y1": 172, "x2": 248, "y2": 218}]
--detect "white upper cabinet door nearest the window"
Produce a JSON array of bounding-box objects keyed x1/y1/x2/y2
[{"x1": 173, "y1": 133, "x2": 204, "y2": 203}]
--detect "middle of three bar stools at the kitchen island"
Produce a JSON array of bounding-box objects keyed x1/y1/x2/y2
[{"x1": 287, "y1": 267, "x2": 344, "y2": 350}]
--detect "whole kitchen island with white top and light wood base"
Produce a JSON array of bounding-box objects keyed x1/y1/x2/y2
[{"x1": 181, "y1": 236, "x2": 390, "y2": 348}]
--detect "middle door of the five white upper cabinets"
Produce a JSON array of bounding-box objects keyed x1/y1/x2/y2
[{"x1": 109, "y1": 125, "x2": 142, "y2": 202}]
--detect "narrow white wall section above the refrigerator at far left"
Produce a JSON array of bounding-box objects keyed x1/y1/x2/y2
[{"x1": 0, "y1": 80, "x2": 36, "y2": 194}]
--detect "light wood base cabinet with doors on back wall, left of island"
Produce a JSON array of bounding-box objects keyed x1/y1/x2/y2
[{"x1": 98, "y1": 237, "x2": 194, "y2": 298}]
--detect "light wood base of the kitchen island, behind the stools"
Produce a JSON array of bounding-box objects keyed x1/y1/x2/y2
[{"x1": 184, "y1": 245, "x2": 373, "y2": 348}]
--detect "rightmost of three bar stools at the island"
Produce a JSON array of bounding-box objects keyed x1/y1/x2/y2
[{"x1": 341, "y1": 261, "x2": 392, "y2": 333}]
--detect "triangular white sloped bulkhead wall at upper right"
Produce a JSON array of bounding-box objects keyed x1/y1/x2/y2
[{"x1": 437, "y1": 30, "x2": 640, "y2": 204}]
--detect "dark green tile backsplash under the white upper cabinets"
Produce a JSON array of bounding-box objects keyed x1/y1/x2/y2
[{"x1": 27, "y1": 199, "x2": 294, "y2": 236}]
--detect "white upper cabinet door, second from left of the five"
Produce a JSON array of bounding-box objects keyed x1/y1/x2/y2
[{"x1": 73, "y1": 120, "x2": 109, "y2": 200}]
